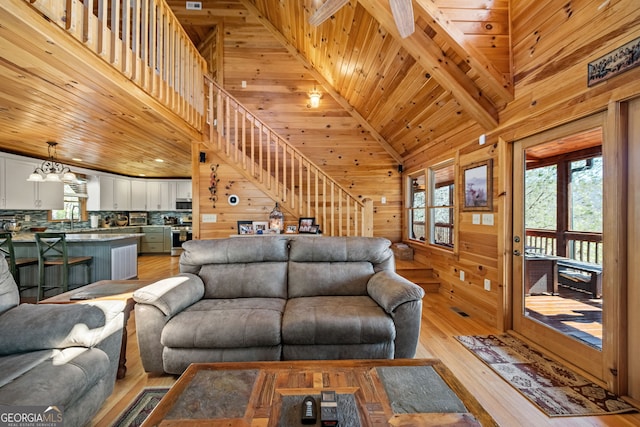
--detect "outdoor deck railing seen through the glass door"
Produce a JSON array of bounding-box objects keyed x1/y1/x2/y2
[{"x1": 525, "y1": 229, "x2": 603, "y2": 265}]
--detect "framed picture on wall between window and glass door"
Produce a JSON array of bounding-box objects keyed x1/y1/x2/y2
[{"x1": 462, "y1": 159, "x2": 493, "y2": 211}]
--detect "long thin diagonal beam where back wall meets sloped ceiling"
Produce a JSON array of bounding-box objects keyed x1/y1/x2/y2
[{"x1": 235, "y1": 0, "x2": 402, "y2": 164}]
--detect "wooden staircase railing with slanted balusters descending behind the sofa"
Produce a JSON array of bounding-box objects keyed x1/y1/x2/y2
[{"x1": 205, "y1": 78, "x2": 373, "y2": 236}]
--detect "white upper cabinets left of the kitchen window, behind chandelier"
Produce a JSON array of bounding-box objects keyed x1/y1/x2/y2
[{"x1": 2, "y1": 158, "x2": 64, "y2": 210}]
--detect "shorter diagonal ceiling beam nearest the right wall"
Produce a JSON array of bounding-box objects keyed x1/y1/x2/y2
[{"x1": 415, "y1": 0, "x2": 513, "y2": 103}]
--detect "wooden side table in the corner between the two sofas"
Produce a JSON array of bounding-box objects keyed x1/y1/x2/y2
[{"x1": 40, "y1": 280, "x2": 154, "y2": 379}]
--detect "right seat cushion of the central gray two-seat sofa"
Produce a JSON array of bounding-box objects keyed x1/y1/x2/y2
[{"x1": 282, "y1": 296, "x2": 396, "y2": 345}]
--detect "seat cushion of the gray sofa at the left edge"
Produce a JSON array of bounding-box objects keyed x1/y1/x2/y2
[{"x1": 0, "y1": 347, "x2": 110, "y2": 407}]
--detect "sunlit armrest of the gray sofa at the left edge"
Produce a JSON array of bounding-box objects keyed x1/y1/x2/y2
[{"x1": 0, "y1": 301, "x2": 125, "y2": 355}]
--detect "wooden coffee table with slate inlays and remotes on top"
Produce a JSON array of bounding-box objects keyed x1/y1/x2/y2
[{"x1": 143, "y1": 359, "x2": 496, "y2": 427}]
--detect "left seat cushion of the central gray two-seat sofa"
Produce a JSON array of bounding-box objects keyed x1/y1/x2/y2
[{"x1": 160, "y1": 298, "x2": 286, "y2": 348}]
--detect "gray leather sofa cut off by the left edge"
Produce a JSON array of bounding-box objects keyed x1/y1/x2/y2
[{"x1": 0, "y1": 257, "x2": 124, "y2": 427}]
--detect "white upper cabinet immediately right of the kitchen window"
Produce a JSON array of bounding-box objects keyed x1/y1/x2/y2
[{"x1": 87, "y1": 175, "x2": 131, "y2": 211}]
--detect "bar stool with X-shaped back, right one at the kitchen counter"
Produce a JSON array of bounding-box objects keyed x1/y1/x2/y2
[{"x1": 36, "y1": 233, "x2": 93, "y2": 301}]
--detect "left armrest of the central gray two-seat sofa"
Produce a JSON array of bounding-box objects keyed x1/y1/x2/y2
[{"x1": 133, "y1": 273, "x2": 204, "y2": 318}]
